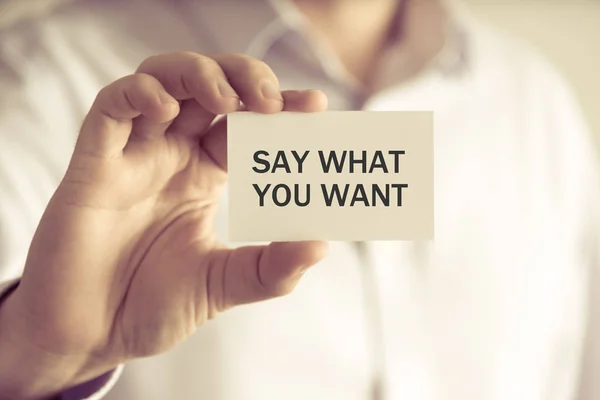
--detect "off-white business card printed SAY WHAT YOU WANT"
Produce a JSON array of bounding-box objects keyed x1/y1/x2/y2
[{"x1": 228, "y1": 111, "x2": 433, "y2": 242}]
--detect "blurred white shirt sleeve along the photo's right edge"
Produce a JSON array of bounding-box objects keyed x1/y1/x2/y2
[{"x1": 544, "y1": 57, "x2": 600, "y2": 400}]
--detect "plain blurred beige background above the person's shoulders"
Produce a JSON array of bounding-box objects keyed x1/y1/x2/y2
[{"x1": 0, "y1": 0, "x2": 600, "y2": 139}]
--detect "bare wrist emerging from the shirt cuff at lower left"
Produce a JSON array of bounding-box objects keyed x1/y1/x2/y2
[{"x1": 0, "y1": 289, "x2": 112, "y2": 400}]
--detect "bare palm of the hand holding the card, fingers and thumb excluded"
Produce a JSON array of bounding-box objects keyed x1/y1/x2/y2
[{"x1": 15, "y1": 114, "x2": 226, "y2": 358}]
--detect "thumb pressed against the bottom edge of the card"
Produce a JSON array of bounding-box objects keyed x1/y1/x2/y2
[{"x1": 214, "y1": 242, "x2": 328, "y2": 311}]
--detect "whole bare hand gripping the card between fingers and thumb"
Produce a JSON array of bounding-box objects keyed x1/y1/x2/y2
[{"x1": 0, "y1": 53, "x2": 327, "y2": 398}]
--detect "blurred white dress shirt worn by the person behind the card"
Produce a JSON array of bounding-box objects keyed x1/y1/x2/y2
[{"x1": 0, "y1": 0, "x2": 600, "y2": 400}]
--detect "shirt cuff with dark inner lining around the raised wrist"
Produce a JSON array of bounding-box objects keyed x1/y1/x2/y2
[{"x1": 0, "y1": 279, "x2": 123, "y2": 400}]
